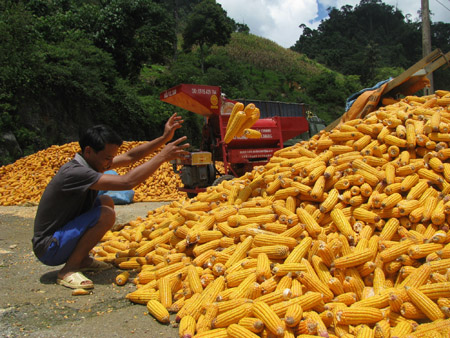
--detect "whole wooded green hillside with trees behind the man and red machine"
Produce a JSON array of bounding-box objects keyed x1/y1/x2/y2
[{"x1": 5, "y1": 0, "x2": 440, "y2": 163}]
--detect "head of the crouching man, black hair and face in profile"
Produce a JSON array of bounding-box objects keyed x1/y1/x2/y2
[{"x1": 79, "y1": 125, "x2": 123, "y2": 172}]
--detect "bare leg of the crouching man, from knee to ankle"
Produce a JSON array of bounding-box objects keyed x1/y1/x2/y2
[{"x1": 58, "y1": 195, "x2": 116, "y2": 284}]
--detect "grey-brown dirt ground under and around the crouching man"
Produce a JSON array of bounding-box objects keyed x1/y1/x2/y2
[{"x1": 0, "y1": 202, "x2": 182, "y2": 338}]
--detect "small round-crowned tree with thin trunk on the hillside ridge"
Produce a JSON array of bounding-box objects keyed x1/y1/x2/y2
[{"x1": 183, "y1": 0, "x2": 234, "y2": 73}]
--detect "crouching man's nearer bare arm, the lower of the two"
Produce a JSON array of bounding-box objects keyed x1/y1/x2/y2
[{"x1": 90, "y1": 136, "x2": 190, "y2": 190}]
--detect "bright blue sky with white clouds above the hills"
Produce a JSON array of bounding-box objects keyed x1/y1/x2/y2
[{"x1": 216, "y1": 0, "x2": 450, "y2": 48}]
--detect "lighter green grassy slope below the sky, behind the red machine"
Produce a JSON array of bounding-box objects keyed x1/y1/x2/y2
[{"x1": 207, "y1": 33, "x2": 356, "y2": 121}]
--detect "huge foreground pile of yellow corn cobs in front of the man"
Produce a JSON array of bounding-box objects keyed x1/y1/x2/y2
[{"x1": 93, "y1": 91, "x2": 450, "y2": 338}]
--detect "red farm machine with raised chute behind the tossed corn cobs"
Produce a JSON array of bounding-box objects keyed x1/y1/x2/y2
[{"x1": 160, "y1": 84, "x2": 308, "y2": 193}]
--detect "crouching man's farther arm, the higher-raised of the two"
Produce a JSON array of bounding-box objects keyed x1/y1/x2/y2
[{"x1": 110, "y1": 113, "x2": 183, "y2": 169}]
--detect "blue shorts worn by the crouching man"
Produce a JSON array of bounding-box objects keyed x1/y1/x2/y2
[{"x1": 40, "y1": 198, "x2": 101, "y2": 266}]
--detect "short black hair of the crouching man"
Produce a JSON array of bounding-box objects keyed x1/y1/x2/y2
[{"x1": 78, "y1": 124, "x2": 123, "y2": 152}]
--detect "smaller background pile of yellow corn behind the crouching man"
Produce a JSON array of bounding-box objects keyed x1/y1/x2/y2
[{"x1": 0, "y1": 141, "x2": 191, "y2": 206}]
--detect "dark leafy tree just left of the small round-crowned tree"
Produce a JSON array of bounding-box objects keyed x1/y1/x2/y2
[{"x1": 94, "y1": 0, "x2": 176, "y2": 80}]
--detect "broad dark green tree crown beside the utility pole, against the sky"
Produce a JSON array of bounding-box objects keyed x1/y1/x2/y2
[{"x1": 293, "y1": 0, "x2": 421, "y2": 85}]
